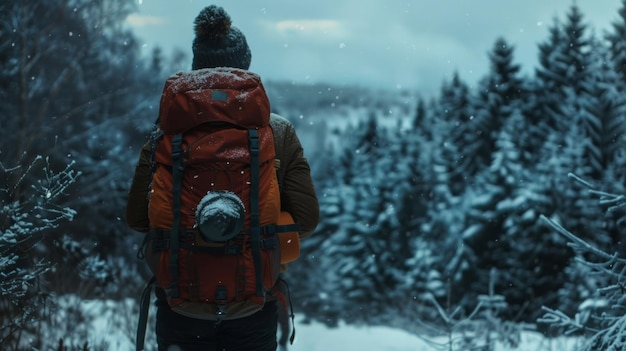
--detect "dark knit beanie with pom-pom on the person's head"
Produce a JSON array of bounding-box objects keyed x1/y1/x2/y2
[{"x1": 191, "y1": 5, "x2": 252, "y2": 70}]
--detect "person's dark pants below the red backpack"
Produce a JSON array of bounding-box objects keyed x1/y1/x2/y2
[{"x1": 156, "y1": 288, "x2": 278, "y2": 351}]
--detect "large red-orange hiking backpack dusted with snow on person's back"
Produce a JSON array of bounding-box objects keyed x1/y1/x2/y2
[{"x1": 137, "y1": 68, "x2": 299, "y2": 349}]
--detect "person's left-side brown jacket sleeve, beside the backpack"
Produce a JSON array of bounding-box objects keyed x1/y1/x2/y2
[{"x1": 126, "y1": 142, "x2": 152, "y2": 233}]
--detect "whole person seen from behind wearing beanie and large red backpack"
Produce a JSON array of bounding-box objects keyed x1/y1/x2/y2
[{"x1": 126, "y1": 5, "x2": 319, "y2": 351}]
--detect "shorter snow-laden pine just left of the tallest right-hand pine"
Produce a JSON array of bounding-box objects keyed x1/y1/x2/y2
[{"x1": 486, "y1": 114, "x2": 570, "y2": 323}]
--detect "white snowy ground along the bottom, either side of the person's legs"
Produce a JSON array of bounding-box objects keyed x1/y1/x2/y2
[{"x1": 52, "y1": 300, "x2": 580, "y2": 351}]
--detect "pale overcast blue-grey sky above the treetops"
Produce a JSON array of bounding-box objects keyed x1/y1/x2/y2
[{"x1": 128, "y1": 0, "x2": 622, "y2": 95}]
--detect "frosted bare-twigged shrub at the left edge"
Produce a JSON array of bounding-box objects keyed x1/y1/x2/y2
[{"x1": 0, "y1": 157, "x2": 80, "y2": 349}]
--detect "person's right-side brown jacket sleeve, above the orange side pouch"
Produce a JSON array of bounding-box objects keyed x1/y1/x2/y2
[{"x1": 272, "y1": 114, "x2": 319, "y2": 237}]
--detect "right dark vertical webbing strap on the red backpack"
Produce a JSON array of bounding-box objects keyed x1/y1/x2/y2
[{"x1": 248, "y1": 129, "x2": 265, "y2": 296}]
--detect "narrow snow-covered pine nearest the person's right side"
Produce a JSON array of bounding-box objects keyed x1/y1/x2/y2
[{"x1": 328, "y1": 113, "x2": 402, "y2": 323}]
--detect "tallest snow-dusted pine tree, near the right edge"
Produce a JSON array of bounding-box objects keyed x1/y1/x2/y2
[{"x1": 531, "y1": 5, "x2": 621, "y2": 300}]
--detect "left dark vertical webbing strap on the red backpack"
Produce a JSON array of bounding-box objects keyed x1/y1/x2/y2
[{"x1": 169, "y1": 133, "x2": 184, "y2": 297}]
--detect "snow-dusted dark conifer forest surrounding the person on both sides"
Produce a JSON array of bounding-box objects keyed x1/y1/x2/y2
[{"x1": 0, "y1": 0, "x2": 626, "y2": 350}]
